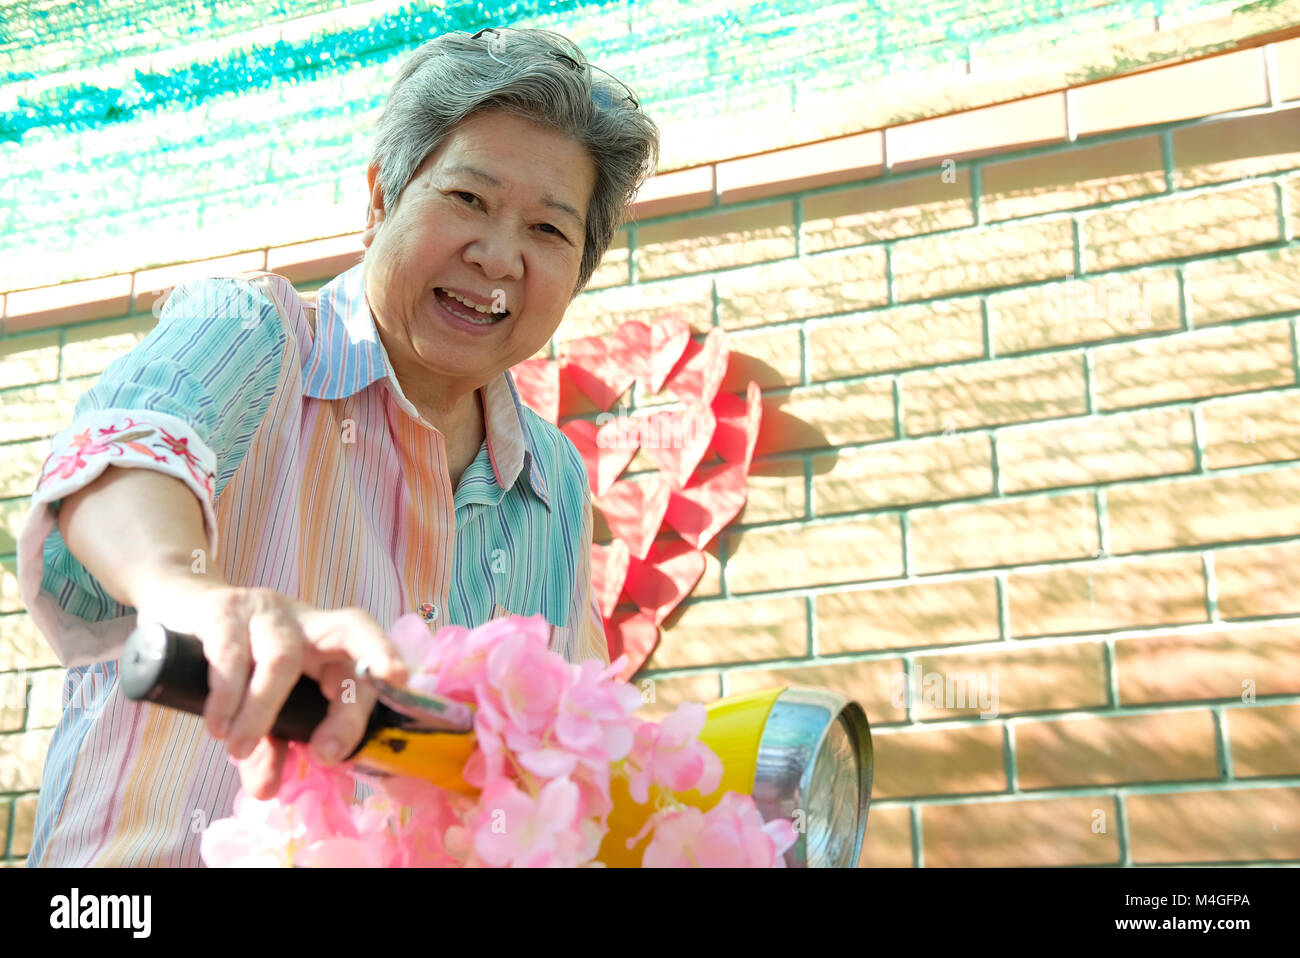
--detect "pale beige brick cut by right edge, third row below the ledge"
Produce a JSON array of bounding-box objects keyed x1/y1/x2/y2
[{"x1": 1184, "y1": 248, "x2": 1300, "y2": 326}]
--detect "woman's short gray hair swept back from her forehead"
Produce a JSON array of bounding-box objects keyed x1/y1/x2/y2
[{"x1": 371, "y1": 29, "x2": 659, "y2": 296}]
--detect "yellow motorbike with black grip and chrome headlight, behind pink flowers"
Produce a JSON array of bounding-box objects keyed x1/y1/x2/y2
[{"x1": 118, "y1": 624, "x2": 872, "y2": 868}]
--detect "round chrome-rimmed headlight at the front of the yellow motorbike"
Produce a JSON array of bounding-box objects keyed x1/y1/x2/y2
[{"x1": 753, "y1": 688, "x2": 872, "y2": 868}]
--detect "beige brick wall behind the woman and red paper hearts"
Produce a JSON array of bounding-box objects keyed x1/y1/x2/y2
[{"x1": 0, "y1": 40, "x2": 1300, "y2": 866}]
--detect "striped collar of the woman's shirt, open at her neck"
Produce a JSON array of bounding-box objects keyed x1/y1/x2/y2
[{"x1": 303, "y1": 263, "x2": 551, "y2": 510}]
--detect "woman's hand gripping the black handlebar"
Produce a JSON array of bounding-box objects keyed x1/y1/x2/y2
[{"x1": 137, "y1": 571, "x2": 408, "y2": 801}]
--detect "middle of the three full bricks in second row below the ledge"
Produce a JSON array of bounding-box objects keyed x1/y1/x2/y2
[{"x1": 892, "y1": 220, "x2": 1074, "y2": 300}]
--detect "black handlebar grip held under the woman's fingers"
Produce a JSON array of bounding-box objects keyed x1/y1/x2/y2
[{"x1": 117, "y1": 623, "x2": 351, "y2": 754}]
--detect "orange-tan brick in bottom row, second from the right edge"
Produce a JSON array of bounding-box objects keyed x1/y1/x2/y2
[{"x1": 920, "y1": 796, "x2": 1119, "y2": 868}]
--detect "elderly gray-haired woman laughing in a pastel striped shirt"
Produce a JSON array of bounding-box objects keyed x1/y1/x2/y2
[{"x1": 20, "y1": 30, "x2": 659, "y2": 866}]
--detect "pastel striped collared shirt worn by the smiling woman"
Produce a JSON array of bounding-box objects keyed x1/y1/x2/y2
[{"x1": 18, "y1": 265, "x2": 608, "y2": 866}]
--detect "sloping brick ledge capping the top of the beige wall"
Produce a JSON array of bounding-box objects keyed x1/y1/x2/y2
[{"x1": 12, "y1": 37, "x2": 1300, "y2": 321}]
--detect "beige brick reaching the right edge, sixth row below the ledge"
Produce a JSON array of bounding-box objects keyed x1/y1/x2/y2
[{"x1": 1106, "y1": 468, "x2": 1300, "y2": 555}]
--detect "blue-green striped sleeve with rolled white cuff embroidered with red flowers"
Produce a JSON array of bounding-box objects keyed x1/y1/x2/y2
[{"x1": 18, "y1": 278, "x2": 286, "y2": 667}]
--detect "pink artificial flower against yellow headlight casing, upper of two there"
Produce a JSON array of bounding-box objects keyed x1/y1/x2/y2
[{"x1": 624, "y1": 702, "x2": 723, "y2": 805}]
